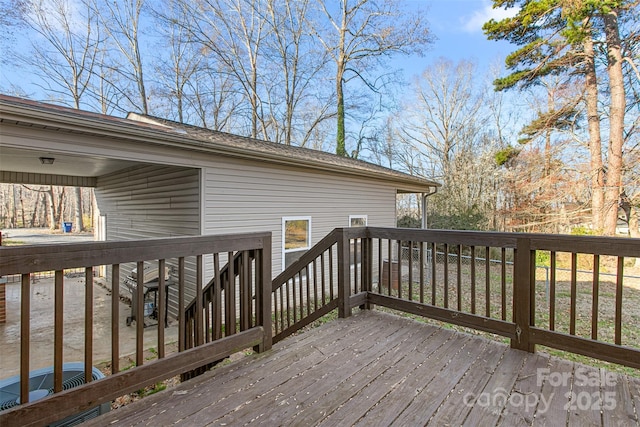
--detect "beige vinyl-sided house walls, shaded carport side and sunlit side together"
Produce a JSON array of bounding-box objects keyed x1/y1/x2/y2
[{"x1": 96, "y1": 158, "x2": 396, "y2": 316}]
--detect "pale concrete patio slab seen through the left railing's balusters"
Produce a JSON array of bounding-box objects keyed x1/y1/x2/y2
[{"x1": 0, "y1": 277, "x2": 178, "y2": 379}]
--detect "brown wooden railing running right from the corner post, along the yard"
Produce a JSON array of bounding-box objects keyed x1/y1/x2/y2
[{"x1": 363, "y1": 227, "x2": 640, "y2": 368}]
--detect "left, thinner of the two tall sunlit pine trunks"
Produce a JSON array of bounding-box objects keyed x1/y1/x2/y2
[{"x1": 584, "y1": 35, "x2": 604, "y2": 232}]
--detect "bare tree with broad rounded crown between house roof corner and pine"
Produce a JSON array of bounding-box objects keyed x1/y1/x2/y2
[{"x1": 397, "y1": 59, "x2": 514, "y2": 229}]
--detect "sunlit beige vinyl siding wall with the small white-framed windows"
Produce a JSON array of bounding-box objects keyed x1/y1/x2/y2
[{"x1": 203, "y1": 160, "x2": 396, "y2": 276}]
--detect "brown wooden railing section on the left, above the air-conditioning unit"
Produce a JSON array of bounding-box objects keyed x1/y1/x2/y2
[{"x1": 0, "y1": 233, "x2": 272, "y2": 426}]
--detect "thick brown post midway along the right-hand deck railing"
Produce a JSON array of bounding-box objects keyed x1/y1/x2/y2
[{"x1": 511, "y1": 237, "x2": 535, "y2": 353}]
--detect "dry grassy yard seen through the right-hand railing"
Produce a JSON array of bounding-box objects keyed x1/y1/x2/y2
[{"x1": 374, "y1": 257, "x2": 640, "y2": 377}]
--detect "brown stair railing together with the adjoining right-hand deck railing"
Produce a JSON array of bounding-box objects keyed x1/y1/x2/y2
[{"x1": 272, "y1": 227, "x2": 640, "y2": 368}]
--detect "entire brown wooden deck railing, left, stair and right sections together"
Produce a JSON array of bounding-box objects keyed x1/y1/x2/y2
[{"x1": 0, "y1": 227, "x2": 640, "y2": 425}]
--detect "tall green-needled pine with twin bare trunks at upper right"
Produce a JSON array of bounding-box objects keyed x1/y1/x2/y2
[{"x1": 484, "y1": 0, "x2": 637, "y2": 235}]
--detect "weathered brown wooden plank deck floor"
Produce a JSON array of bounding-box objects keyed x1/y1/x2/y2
[{"x1": 88, "y1": 311, "x2": 640, "y2": 426}]
